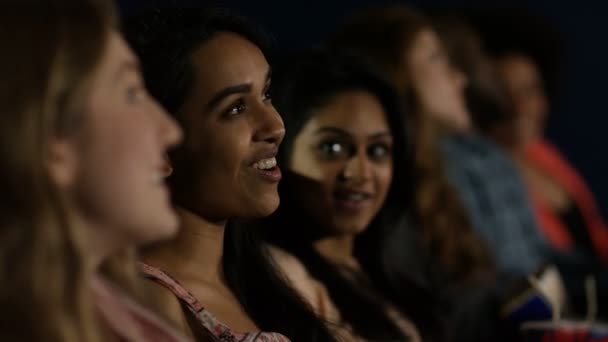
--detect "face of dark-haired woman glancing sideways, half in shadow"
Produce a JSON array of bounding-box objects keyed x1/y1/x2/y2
[{"x1": 289, "y1": 90, "x2": 393, "y2": 235}]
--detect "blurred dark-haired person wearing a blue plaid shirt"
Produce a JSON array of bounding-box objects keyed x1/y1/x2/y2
[{"x1": 434, "y1": 16, "x2": 550, "y2": 284}]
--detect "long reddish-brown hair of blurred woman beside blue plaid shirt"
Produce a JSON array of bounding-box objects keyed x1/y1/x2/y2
[{"x1": 330, "y1": 5, "x2": 493, "y2": 280}]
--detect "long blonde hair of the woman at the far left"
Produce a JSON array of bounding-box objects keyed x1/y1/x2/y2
[{"x1": 0, "y1": 0, "x2": 133, "y2": 341}]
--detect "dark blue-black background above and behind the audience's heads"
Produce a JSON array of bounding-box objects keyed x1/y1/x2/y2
[{"x1": 119, "y1": 0, "x2": 608, "y2": 216}]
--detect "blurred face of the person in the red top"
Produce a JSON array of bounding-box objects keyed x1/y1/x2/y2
[{"x1": 497, "y1": 54, "x2": 549, "y2": 145}]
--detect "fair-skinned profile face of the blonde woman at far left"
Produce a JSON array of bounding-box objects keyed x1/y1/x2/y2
[{"x1": 50, "y1": 32, "x2": 181, "y2": 248}]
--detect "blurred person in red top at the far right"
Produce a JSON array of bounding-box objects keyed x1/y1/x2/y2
[{"x1": 496, "y1": 52, "x2": 608, "y2": 318}]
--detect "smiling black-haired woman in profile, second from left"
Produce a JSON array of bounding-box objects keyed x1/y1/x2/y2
[{"x1": 125, "y1": 8, "x2": 333, "y2": 342}]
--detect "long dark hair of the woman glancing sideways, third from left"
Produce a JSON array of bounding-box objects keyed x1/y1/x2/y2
[{"x1": 257, "y1": 50, "x2": 440, "y2": 340}]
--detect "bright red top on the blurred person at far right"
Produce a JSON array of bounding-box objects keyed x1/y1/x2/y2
[{"x1": 525, "y1": 140, "x2": 608, "y2": 264}]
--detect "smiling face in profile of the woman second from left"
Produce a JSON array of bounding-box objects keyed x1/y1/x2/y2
[{"x1": 183, "y1": 32, "x2": 285, "y2": 222}]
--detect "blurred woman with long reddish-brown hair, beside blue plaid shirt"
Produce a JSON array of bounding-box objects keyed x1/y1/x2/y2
[{"x1": 329, "y1": 6, "x2": 493, "y2": 288}]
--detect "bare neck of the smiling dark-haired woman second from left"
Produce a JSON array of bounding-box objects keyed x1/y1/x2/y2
[{"x1": 143, "y1": 208, "x2": 226, "y2": 284}]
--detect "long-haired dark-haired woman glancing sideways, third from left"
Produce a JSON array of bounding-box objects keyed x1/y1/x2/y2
[{"x1": 257, "y1": 51, "x2": 440, "y2": 341}]
